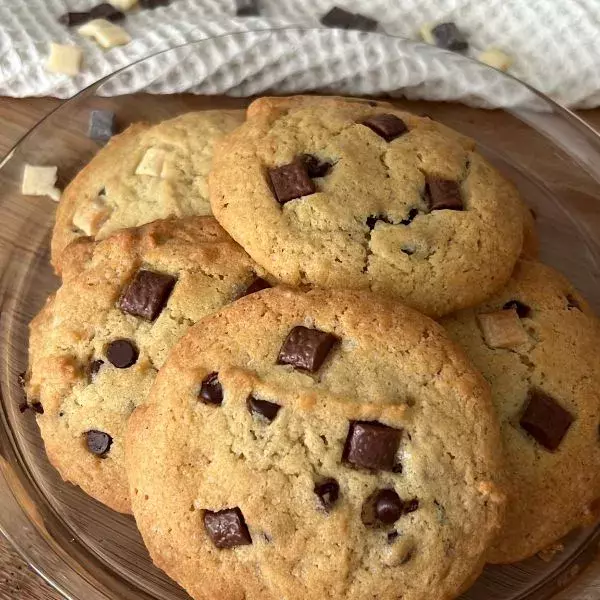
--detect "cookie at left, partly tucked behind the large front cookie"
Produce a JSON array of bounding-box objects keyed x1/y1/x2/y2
[{"x1": 26, "y1": 217, "x2": 268, "y2": 512}]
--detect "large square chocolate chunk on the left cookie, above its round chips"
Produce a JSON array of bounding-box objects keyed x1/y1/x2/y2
[{"x1": 119, "y1": 269, "x2": 175, "y2": 321}]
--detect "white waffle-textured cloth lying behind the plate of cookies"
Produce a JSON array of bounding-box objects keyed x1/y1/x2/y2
[{"x1": 0, "y1": 0, "x2": 600, "y2": 107}]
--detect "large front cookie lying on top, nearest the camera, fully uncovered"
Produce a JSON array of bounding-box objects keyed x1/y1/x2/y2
[{"x1": 126, "y1": 289, "x2": 503, "y2": 600}]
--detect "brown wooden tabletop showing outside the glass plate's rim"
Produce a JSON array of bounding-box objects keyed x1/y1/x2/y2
[{"x1": 0, "y1": 98, "x2": 600, "y2": 600}]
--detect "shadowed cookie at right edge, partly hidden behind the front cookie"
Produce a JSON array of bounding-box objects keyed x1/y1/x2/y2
[{"x1": 442, "y1": 261, "x2": 600, "y2": 563}]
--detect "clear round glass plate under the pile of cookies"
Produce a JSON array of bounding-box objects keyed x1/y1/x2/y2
[{"x1": 0, "y1": 29, "x2": 600, "y2": 600}]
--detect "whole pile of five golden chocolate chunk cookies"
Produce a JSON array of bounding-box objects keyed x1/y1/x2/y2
[{"x1": 26, "y1": 96, "x2": 600, "y2": 600}]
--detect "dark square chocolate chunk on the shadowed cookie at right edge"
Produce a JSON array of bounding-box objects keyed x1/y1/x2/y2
[{"x1": 519, "y1": 390, "x2": 574, "y2": 450}]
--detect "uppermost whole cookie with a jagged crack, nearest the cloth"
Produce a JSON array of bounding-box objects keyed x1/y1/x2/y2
[{"x1": 209, "y1": 98, "x2": 523, "y2": 316}]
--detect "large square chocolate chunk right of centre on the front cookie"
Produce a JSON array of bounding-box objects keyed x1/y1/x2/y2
[{"x1": 342, "y1": 421, "x2": 402, "y2": 471}]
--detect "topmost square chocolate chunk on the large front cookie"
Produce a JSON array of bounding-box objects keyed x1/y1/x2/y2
[{"x1": 277, "y1": 325, "x2": 338, "y2": 373}]
